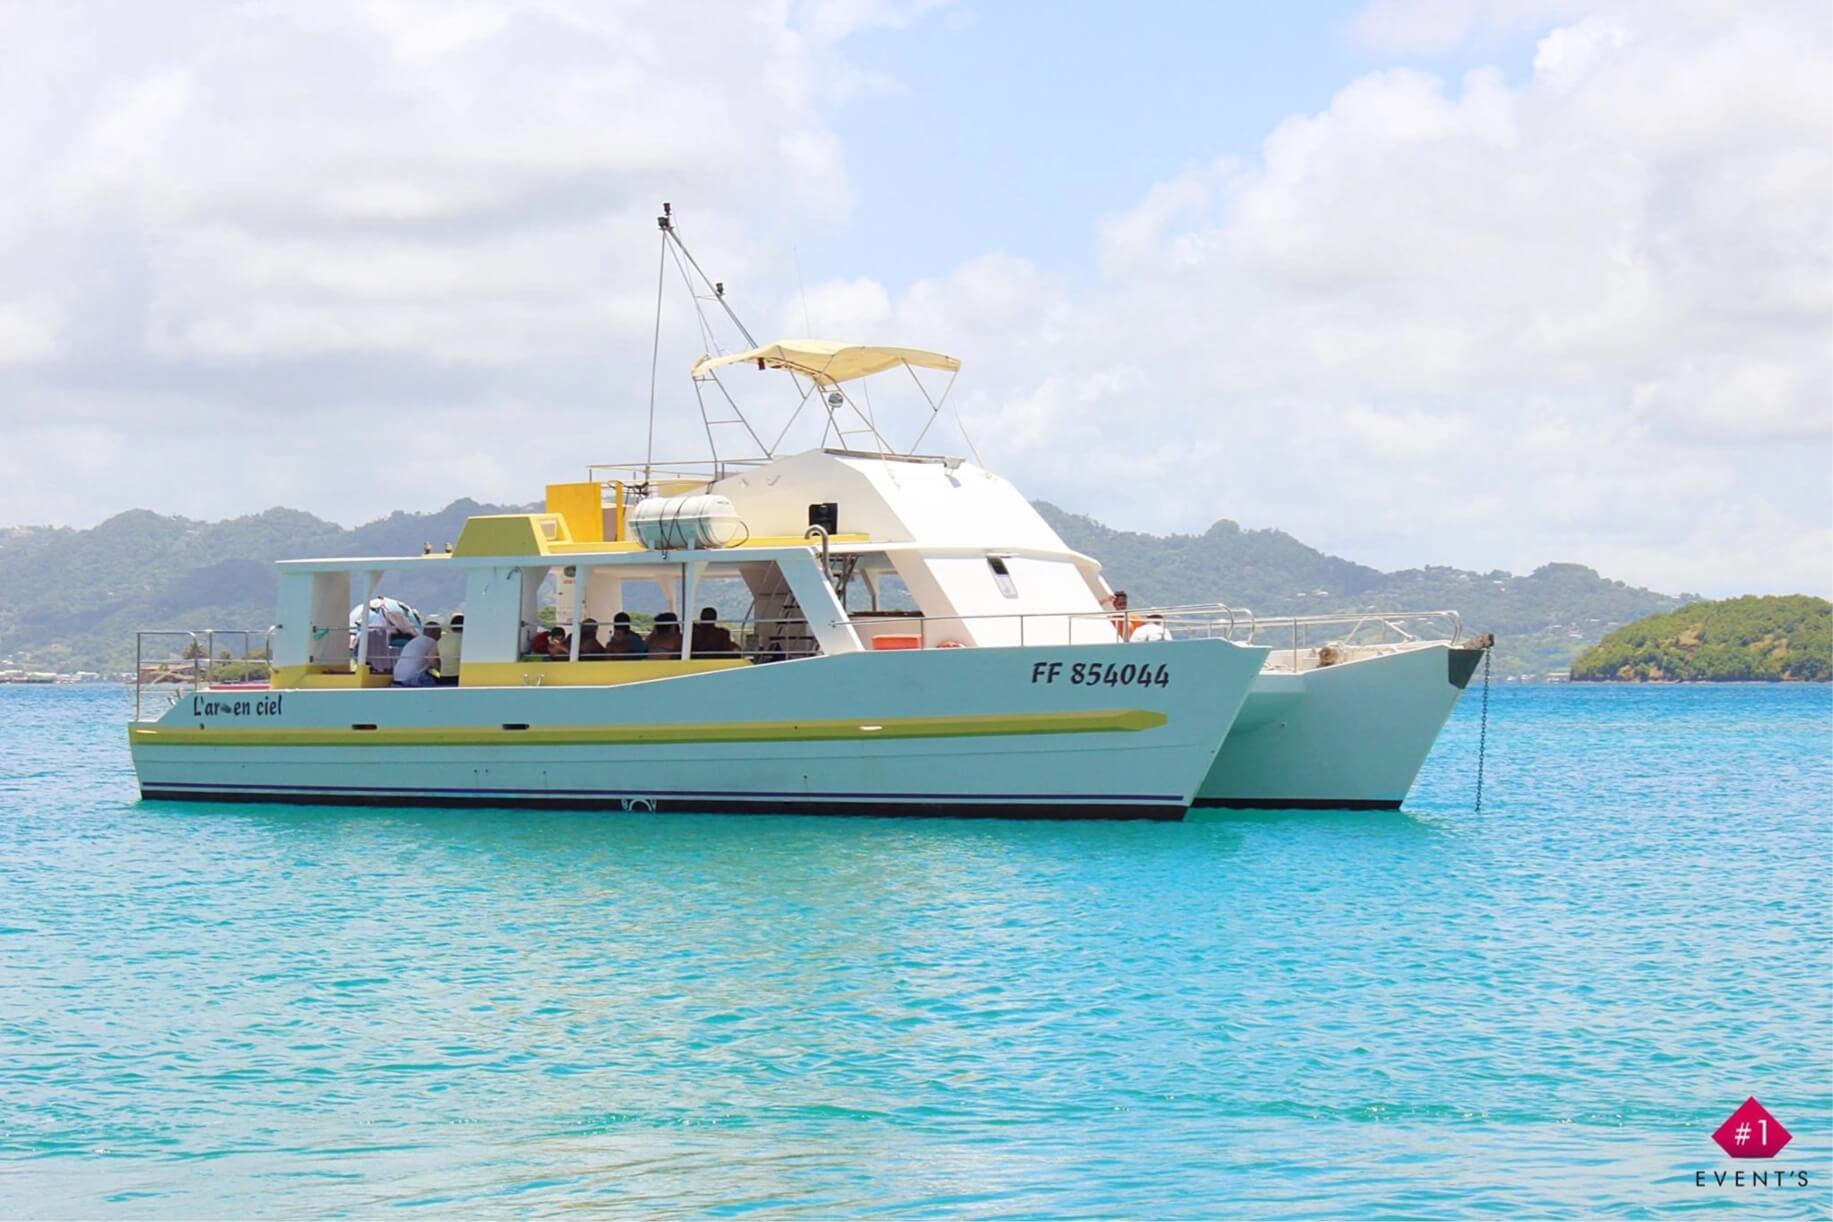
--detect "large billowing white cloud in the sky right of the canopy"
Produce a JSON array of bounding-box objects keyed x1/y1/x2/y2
[{"x1": 806, "y1": 5, "x2": 1833, "y2": 590}]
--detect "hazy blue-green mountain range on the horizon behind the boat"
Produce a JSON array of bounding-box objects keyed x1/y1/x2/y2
[{"x1": 0, "y1": 500, "x2": 1696, "y2": 676}]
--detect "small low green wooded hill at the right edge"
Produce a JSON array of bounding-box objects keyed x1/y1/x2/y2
[{"x1": 1573, "y1": 594, "x2": 1833, "y2": 683}]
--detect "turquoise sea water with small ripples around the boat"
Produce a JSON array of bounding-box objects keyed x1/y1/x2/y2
[{"x1": 0, "y1": 685, "x2": 1833, "y2": 1217}]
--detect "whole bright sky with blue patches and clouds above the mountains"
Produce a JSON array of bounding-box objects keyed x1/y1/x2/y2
[{"x1": 0, "y1": 0, "x2": 1833, "y2": 595}]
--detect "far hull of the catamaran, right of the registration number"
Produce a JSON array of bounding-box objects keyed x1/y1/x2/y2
[{"x1": 1193, "y1": 645, "x2": 1481, "y2": 810}]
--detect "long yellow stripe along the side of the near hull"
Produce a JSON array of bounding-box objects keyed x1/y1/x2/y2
[{"x1": 128, "y1": 709, "x2": 1168, "y2": 747}]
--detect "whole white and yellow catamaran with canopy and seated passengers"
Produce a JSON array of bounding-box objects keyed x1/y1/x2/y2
[{"x1": 128, "y1": 224, "x2": 1481, "y2": 819}]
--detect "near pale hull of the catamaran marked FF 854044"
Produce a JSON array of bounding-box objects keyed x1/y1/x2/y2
[{"x1": 130, "y1": 641, "x2": 1265, "y2": 819}]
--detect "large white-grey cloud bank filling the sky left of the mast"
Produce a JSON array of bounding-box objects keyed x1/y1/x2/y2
[{"x1": 0, "y1": 0, "x2": 905, "y2": 522}]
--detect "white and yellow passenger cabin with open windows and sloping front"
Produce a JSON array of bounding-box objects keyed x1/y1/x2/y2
[{"x1": 273, "y1": 451, "x2": 1116, "y2": 687}]
